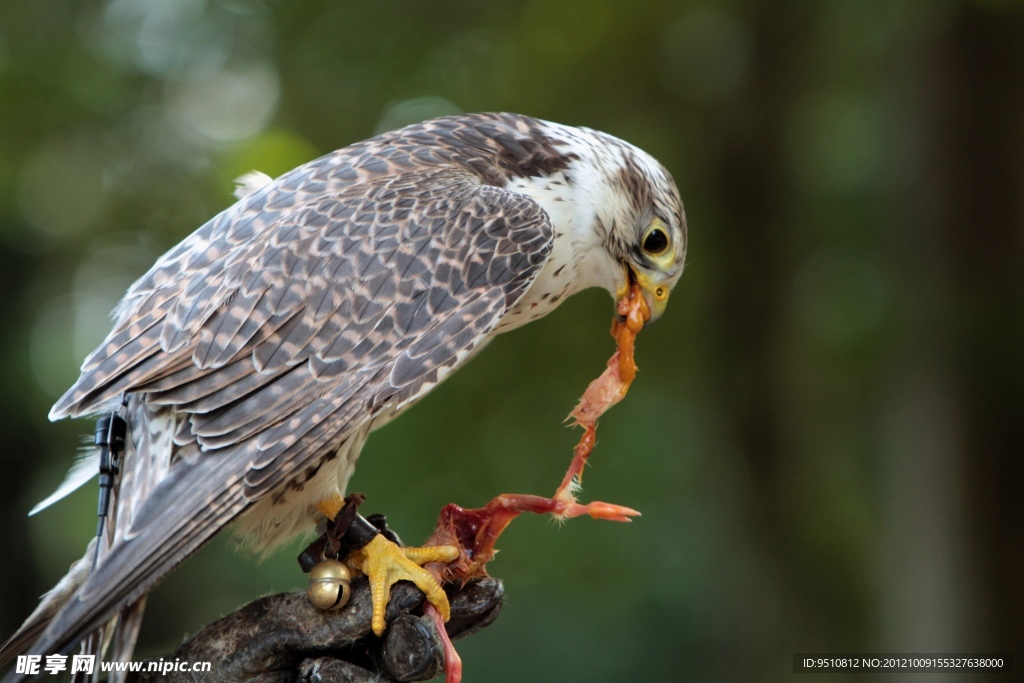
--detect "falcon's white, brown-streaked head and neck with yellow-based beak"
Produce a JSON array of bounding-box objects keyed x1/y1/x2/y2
[{"x1": 495, "y1": 120, "x2": 686, "y2": 322}]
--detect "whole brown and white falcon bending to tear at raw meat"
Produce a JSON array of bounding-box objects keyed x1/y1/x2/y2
[{"x1": 0, "y1": 114, "x2": 686, "y2": 666}]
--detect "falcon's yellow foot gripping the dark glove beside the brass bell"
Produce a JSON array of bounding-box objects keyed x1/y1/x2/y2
[{"x1": 359, "y1": 533, "x2": 459, "y2": 636}]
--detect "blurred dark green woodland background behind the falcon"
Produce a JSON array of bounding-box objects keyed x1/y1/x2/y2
[{"x1": 0, "y1": 0, "x2": 1024, "y2": 682}]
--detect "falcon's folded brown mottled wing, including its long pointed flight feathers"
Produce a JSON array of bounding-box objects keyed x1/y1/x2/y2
[{"x1": 33, "y1": 155, "x2": 552, "y2": 653}]
